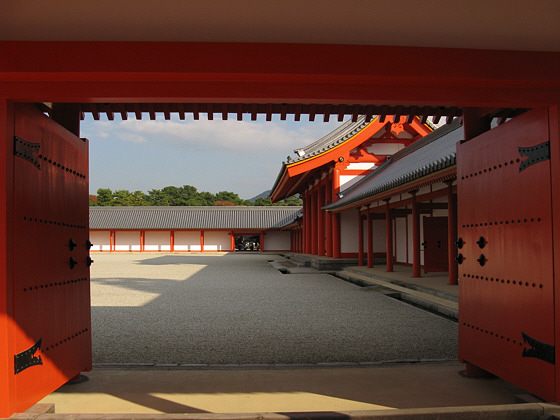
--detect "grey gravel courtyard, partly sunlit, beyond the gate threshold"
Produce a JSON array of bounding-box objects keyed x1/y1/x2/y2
[{"x1": 91, "y1": 253, "x2": 457, "y2": 364}]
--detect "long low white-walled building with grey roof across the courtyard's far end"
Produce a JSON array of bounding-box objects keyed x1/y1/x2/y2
[{"x1": 89, "y1": 206, "x2": 301, "y2": 252}]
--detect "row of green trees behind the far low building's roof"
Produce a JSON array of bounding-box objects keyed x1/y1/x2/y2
[{"x1": 89, "y1": 185, "x2": 302, "y2": 206}]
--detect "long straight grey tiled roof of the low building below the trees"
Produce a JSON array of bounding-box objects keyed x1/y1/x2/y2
[{"x1": 89, "y1": 206, "x2": 301, "y2": 230}]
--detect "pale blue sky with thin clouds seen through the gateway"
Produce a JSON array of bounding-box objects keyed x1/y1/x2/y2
[{"x1": 81, "y1": 115, "x2": 341, "y2": 199}]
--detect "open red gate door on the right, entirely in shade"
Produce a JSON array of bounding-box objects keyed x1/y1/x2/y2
[{"x1": 457, "y1": 109, "x2": 555, "y2": 401}]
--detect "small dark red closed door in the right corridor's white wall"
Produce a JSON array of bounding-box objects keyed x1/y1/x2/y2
[{"x1": 423, "y1": 217, "x2": 449, "y2": 273}]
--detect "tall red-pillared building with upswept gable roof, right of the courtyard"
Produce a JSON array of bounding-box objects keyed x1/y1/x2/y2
[{"x1": 271, "y1": 117, "x2": 463, "y2": 284}]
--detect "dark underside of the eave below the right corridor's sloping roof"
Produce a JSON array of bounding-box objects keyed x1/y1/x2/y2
[{"x1": 324, "y1": 163, "x2": 457, "y2": 213}]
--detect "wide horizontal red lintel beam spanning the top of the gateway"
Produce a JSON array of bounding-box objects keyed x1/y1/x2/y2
[{"x1": 0, "y1": 41, "x2": 560, "y2": 107}]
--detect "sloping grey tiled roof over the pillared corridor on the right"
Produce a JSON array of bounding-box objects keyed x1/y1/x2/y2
[{"x1": 324, "y1": 119, "x2": 463, "y2": 210}]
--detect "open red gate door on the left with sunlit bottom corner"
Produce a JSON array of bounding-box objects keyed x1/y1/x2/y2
[{"x1": 12, "y1": 105, "x2": 91, "y2": 411}]
